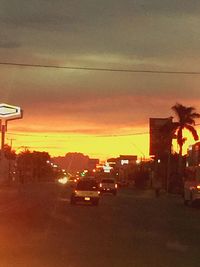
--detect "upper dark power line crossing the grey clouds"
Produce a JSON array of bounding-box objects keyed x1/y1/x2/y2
[{"x1": 0, "y1": 62, "x2": 200, "y2": 75}]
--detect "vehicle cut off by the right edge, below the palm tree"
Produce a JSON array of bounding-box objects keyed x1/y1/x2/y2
[{"x1": 183, "y1": 166, "x2": 200, "y2": 205}]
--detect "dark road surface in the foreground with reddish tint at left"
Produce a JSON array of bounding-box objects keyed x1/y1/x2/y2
[{"x1": 0, "y1": 184, "x2": 200, "y2": 267}]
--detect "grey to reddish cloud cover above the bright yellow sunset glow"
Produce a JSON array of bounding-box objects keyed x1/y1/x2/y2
[{"x1": 0, "y1": 0, "x2": 200, "y2": 133}]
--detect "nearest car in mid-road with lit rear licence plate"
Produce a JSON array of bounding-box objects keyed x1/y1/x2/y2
[{"x1": 70, "y1": 178, "x2": 100, "y2": 206}]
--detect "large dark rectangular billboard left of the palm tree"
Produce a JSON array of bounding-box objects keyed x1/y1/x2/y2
[{"x1": 149, "y1": 117, "x2": 172, "y2": 156}]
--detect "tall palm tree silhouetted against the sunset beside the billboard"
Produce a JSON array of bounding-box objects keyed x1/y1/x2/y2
[{"x1": 172, "y1": 103, "x2": 200, "y2": 156}]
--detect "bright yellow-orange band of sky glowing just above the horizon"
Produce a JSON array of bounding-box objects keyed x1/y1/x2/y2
[{"x1": 6, "y1": 125, "x2": 200, "y2": 160}]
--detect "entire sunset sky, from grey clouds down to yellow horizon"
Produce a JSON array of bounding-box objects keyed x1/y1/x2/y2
[{"x1": 0, "y1": 0, "x2": 200, "y2": 159}]
